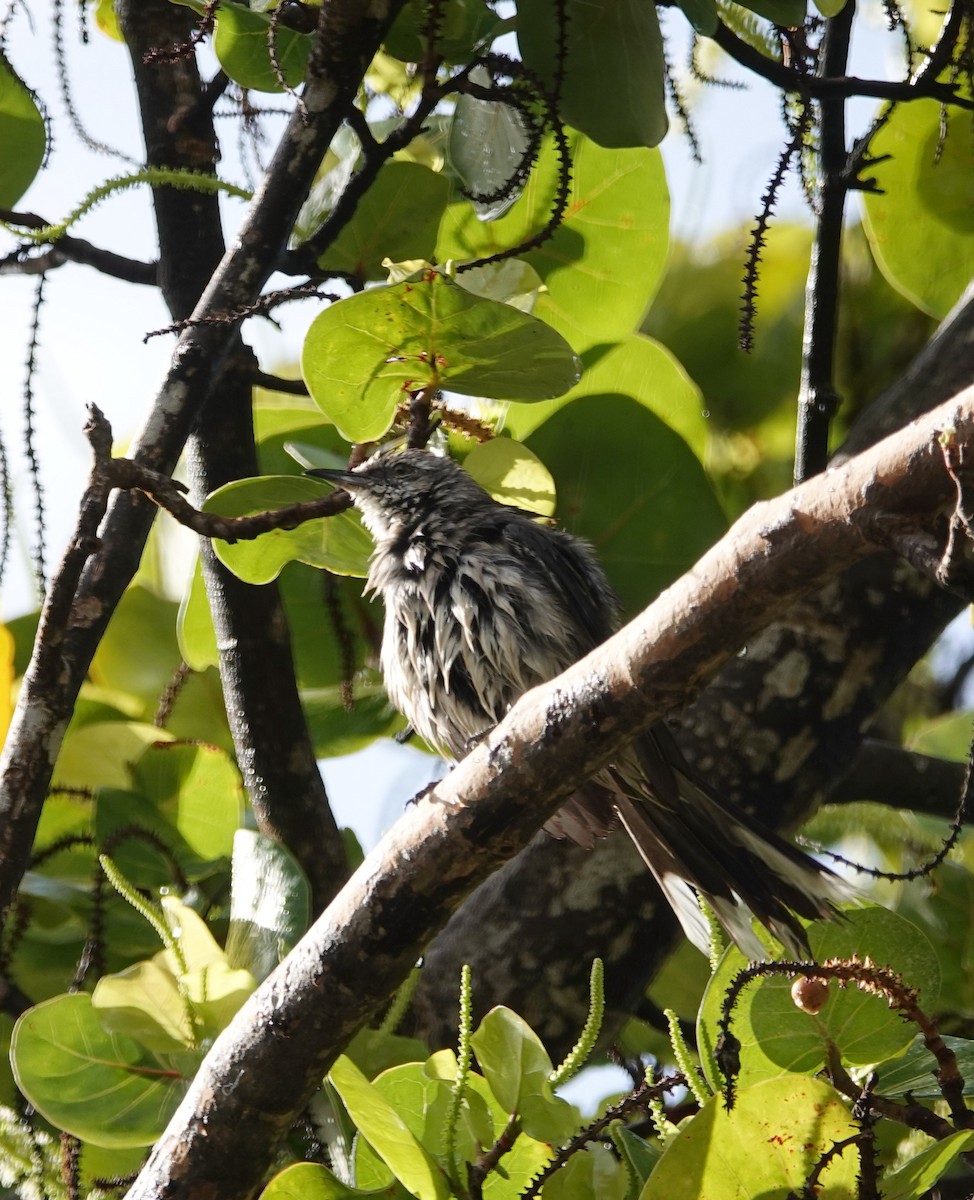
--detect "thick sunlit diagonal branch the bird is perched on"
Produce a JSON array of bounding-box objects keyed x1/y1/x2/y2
[{"x1": 130, "y1": 389, "x2": 974, "y2": 1200}]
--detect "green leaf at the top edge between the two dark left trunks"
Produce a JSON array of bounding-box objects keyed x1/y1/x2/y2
[{"x1": 214, "y1": 0, "x2": 312, "y2": 91}]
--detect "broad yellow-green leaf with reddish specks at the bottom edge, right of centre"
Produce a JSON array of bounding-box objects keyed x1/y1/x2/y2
[{"x1": 641, "y1": 1075, "x2": 854, "y2": 1200}]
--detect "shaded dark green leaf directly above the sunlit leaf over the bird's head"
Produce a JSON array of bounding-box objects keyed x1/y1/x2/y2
[{"x1": 318, "y1": 162, "x2": 450, "y2": 280}]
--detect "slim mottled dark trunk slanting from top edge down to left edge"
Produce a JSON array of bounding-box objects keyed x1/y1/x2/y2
[{"x1": 0, "y1": 0, "x2": 402, "y2": 912}]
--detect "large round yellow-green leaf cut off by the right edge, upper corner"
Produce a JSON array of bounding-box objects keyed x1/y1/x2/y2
[{"x1": 862, "y1": 100, "x2": 974, "y2": 317}]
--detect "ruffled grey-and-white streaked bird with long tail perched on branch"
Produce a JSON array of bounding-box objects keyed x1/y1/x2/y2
[{"x1": 308, "y1": 449, "x2": 849, "y2": 959}]
